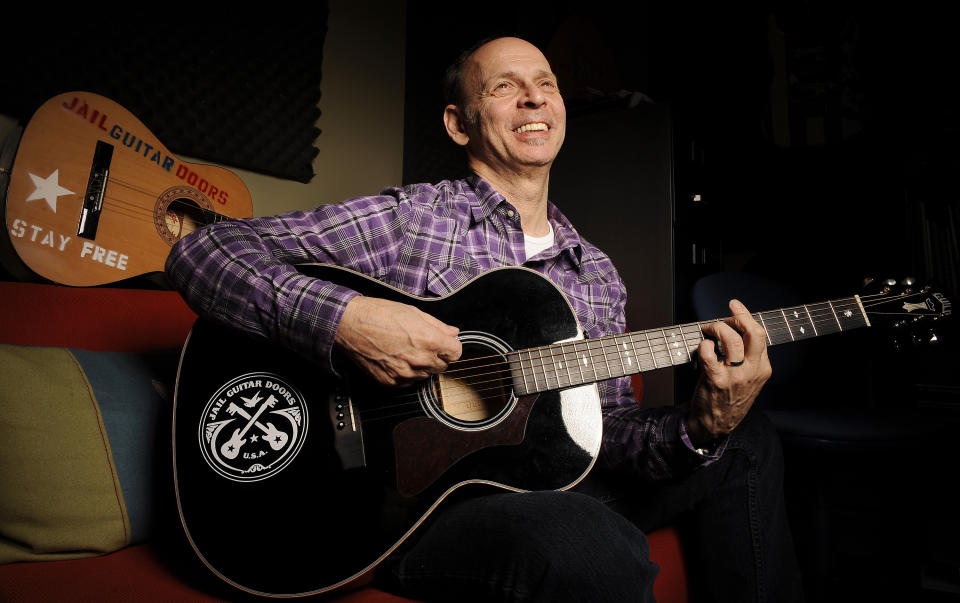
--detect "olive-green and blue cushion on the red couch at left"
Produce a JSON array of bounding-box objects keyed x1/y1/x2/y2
[{"x1": 0, "y1": 344, "x2": 172, "y2": 563}]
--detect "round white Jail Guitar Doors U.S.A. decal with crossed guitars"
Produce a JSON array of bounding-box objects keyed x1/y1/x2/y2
[{"x1": 198, "y1": 373, "x2": 307, "y2": 482}]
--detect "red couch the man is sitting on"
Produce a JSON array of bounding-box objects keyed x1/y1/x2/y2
[{"x1": 0, "y1": 282, "x2": 687, "y2": 603}]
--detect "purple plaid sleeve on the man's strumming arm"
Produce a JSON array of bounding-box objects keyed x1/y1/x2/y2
[{"x1": 166, "y1": 195, "x2": 406, "y2": 373}]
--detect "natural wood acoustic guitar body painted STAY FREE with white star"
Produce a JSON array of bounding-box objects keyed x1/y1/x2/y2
[{"x1": 5, "y1": 92, "x2": 253, "y2": 286}]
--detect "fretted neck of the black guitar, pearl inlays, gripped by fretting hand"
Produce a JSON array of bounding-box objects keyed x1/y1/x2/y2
[{"x1": 510, "y1": 296, "x2": 870, "y2": 395}]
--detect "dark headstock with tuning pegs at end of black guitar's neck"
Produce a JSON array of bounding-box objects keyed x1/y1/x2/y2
[{"x1": 860, "y1": 278, "x2": 952, "y2": 347}]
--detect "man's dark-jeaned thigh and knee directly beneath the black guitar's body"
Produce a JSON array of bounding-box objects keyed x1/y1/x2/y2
[{"x1": 386, "y1": 492, "x2": 658, "y2": 601}]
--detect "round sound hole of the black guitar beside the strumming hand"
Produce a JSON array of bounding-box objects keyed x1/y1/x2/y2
[{"x1": 426, "y1": 333, "x2": 516, "y2": 428}]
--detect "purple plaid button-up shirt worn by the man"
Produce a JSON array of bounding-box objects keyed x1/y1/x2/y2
[{"x1": 166, "y1": 176, "x2": 715, "y2": 479}]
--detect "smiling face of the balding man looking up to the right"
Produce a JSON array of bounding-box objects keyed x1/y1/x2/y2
[{"x1": 463, "y1": 38, "x2": 567, "y2": 171}]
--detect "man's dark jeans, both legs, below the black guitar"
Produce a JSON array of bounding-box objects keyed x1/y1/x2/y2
[{"x1": 379, "y1": 411, "x2": 803, "y2": 602}]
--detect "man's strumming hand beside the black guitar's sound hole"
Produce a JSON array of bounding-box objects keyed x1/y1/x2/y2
[{"x1": 334, "y1": 296, "x2": 463, "y2": 386}]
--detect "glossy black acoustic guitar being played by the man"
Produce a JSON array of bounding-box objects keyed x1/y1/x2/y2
[{"x1": 173, "y1": 265, "x2": 950, "y2": 597}]
